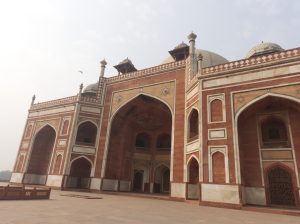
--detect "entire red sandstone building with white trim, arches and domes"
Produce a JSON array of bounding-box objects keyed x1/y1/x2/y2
[{"x1": 11, "y1": 33, "x2": 300, "y2": 207}]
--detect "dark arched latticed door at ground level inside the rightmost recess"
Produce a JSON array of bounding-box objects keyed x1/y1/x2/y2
[{"x1": 267, "y1": 166, "x2": 296, "y2": 206}]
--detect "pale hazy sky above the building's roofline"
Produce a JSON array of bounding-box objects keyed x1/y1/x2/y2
[{"x1": 0, "y1": 0, "x2": 300, "y2": 170}]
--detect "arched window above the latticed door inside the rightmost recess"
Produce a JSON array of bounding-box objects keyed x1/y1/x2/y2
[{"x1": 261, "y1": 117, "x2": 288, "y2": 148}]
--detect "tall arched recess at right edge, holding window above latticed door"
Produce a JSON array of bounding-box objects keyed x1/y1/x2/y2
[{"x1": 237, "y1": 96, "x2": 300, "y2": 206}]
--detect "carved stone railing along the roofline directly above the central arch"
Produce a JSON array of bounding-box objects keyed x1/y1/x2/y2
[{"x1": 106, "y1": 60, "x2": 185, "y2": 83}]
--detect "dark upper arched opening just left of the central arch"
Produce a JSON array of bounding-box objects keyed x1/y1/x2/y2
[{"x1": 76, "y1": 121, "x2": 97, "y2": 146}]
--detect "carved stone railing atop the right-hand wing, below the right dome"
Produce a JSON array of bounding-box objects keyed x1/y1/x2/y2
[{"x1": 202, "y1": 48, "x2": 300, "y2": 75}]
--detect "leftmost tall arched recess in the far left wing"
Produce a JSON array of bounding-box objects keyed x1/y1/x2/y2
[{"x1": 24, "y1": 125, "x2": 56, "y2": 185}]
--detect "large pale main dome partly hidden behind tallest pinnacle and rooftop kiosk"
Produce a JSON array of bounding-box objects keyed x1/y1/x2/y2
[{"x1": 161, "y1": 49, "x2": 228, "y2": 68}]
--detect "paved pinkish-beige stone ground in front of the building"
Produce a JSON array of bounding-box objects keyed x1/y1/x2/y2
[{"x1": 0, "y1": 190, "x2": 300, "y2": 224}]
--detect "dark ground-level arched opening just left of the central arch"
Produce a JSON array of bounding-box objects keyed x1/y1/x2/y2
[{"x1": 67, "y1": 157, "x2": 92, "y2": 189}]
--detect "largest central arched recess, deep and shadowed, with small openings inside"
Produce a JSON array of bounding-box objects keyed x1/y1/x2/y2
[{"x1": 102, "y1": 95, "x2": 172, "y2": 193}]
